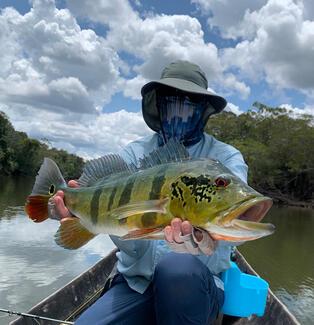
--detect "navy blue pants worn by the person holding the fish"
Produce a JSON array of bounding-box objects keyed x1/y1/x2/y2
[{"x1": 75, "y1": 253, "x2": 224, "y2": 325}]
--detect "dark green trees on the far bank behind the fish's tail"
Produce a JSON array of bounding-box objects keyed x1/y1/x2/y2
[{"x1": 0, "y1": 112, "x2": 84, "y2": 179}]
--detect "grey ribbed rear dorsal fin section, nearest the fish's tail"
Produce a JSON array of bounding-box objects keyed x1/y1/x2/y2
[{"x1": 78, "y1": 154, "x2": 136, "y2": 187}]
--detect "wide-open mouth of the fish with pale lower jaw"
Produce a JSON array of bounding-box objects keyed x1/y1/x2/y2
[{"x1": 206, "y1": 196, "x2": 275, "y2": 242}]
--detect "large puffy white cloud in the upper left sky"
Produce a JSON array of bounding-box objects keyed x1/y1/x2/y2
[{"x1": 0, "y1": 0, "x2": 120, "y2": 113}]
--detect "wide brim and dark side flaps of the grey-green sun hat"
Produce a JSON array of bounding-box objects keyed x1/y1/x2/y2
[{"x1": 141, "y1": 78, "x2": 227, "y2": 132}]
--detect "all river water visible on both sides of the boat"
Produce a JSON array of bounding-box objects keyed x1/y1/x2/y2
[{"x1": 0, "y1": 177, "x2": 314, "y2": 325}]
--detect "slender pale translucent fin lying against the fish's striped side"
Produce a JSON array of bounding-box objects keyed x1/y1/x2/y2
[{"x1": 110, "y1": 198, "x2": 169, "y2": 220}]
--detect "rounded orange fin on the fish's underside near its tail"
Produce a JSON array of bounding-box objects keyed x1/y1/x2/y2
[{"x1": 55, "y1": 217, "x2": 96, "y2": 249}]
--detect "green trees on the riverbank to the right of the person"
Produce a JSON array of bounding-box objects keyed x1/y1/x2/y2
[{"x1": 205, "y1": 103, "x2": 314, "y2": 203}]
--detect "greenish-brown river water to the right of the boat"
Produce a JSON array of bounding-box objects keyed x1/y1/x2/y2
[{"x1": 239, "y1": 207, "x2": 314, "y2": 324}]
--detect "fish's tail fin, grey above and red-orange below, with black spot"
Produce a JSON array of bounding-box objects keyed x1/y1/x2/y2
[{"x1": 25, "y1": 158, "x2": 66, "y2": 222}]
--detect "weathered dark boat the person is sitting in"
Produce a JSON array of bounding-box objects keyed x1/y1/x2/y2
[{"x1": 10, "y1": 250, "x2": 300, "y2": 325}]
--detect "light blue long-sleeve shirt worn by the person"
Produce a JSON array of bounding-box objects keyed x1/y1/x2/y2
[{"x1": 111, "y1": 133, "x2": 247, "y2": 293}]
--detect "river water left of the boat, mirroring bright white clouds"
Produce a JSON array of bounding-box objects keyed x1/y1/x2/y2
[{"x1": 0, "y1": 178, "x2": 114, "y2": 325}]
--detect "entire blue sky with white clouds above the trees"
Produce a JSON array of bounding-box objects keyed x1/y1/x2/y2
[{"x1": 0, "y1": 0, "x2": 314, "y2": 159}]
